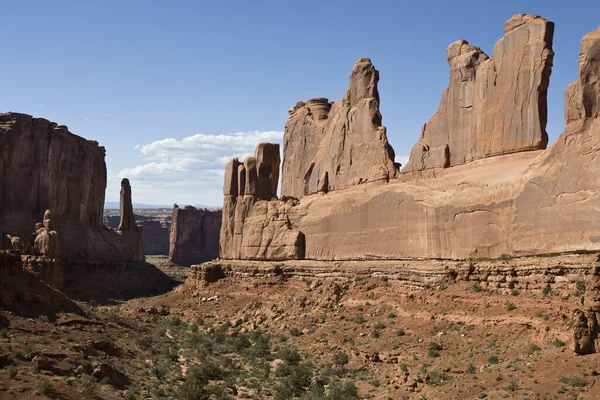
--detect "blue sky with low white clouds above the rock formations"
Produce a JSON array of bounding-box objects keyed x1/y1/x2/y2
[{"x1": 0, "y1": 0, "x2": 600, "y2": 205}]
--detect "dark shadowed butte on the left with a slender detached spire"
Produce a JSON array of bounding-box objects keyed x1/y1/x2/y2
[{"x1": 0, "y1": 113, "x2": 144, "y2": 272}]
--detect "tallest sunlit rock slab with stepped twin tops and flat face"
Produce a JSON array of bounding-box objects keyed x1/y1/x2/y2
[{"x1": 402, "y1": 14, "x2": 554, "y2": 172}]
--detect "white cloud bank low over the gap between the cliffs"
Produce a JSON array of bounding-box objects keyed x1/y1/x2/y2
[{"x1": 118, "y1": 131, "x2": 283, "y2": 206}]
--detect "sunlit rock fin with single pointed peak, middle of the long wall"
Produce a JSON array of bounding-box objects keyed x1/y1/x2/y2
[{"x1": 281, "y1": 58, "x2": 396, "y2": 198}]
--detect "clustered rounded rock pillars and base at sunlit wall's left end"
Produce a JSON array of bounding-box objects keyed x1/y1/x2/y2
[{"x1": 220, "y1": 143, "x2": 304, "y2": 260}]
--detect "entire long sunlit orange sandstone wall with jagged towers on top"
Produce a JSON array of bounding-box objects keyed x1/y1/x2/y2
[{"x1": 220, "y1": 14, "x2": 600, "y2": 260}]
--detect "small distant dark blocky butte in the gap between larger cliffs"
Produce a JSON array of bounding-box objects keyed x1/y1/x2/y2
[{"x1": 169, "y1": 205, "x2": 223, "y2": 266}]
